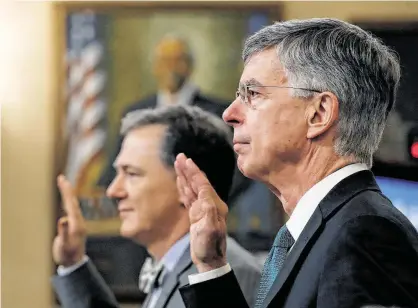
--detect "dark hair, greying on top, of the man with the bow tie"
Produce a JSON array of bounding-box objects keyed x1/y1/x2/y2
[{"x1": 121, "y1": 105, "x2": 235, "y2": 202}]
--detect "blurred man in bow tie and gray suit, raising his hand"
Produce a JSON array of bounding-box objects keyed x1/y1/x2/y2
[{"x1": 53, "y1": 105, "x2": 261, "y2": 308}]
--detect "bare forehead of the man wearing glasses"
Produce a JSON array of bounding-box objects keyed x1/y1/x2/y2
[{"x1": 240, "y1": 48, "x2": 285, "y2": 85}]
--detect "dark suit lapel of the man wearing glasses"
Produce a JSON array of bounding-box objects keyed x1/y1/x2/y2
[{"x1": 262, "y1": 170, "x2": 380, "y2": 308}]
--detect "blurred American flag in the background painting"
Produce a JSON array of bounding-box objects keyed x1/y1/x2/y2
[{"x1": 65, "y1": 13, "x2": 107, "y2": 193}]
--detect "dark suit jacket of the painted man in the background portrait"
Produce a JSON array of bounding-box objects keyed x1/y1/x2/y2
[{"x1": 98, "y1": 92, "x2": 228, "y2": 187}]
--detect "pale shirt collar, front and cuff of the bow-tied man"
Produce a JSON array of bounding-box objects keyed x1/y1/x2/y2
[{"x1": 57, "y1": 233, "x2": 190, "y2": 308}]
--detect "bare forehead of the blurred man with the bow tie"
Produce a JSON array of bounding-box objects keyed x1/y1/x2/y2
[{"x1": 115, "y1": 124, "x2": 167, "y2": 165}]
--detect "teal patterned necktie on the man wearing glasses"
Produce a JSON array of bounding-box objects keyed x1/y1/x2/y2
[{"x1": 255, "y1": 225, "x2": 295, "y2": 308}]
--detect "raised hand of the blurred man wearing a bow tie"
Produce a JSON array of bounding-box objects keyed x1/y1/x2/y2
[{"x1": 52, "y1": 175, "x2": 87, "y2": 267}]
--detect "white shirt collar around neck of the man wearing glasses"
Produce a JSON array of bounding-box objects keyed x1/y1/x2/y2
[{"x1": 286, "y1": 163, "x2": 368, "y2": 242}]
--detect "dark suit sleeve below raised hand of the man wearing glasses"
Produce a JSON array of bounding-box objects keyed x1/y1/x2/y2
[{"x1": 180, "y1": 271, "x2": 249, "y2": 308}]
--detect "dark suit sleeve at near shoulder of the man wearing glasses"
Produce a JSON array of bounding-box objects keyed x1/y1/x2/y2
[{"x1": 317, "y1": 216, "x2": 418, "y2": 308}]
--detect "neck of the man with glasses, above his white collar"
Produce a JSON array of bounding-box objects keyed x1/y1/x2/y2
[{"x1": 267, "y1": 151, "x2": 353, "y2": 216}]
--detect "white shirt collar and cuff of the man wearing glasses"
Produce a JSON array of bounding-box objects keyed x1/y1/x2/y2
[{"x1": 189, "y1": 163, "x2": 368, "y2": 284}]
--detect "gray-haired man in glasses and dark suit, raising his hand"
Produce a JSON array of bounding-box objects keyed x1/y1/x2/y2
[{"x1": 175, "y1": 18, "x2": 418, "y2": 308}]
